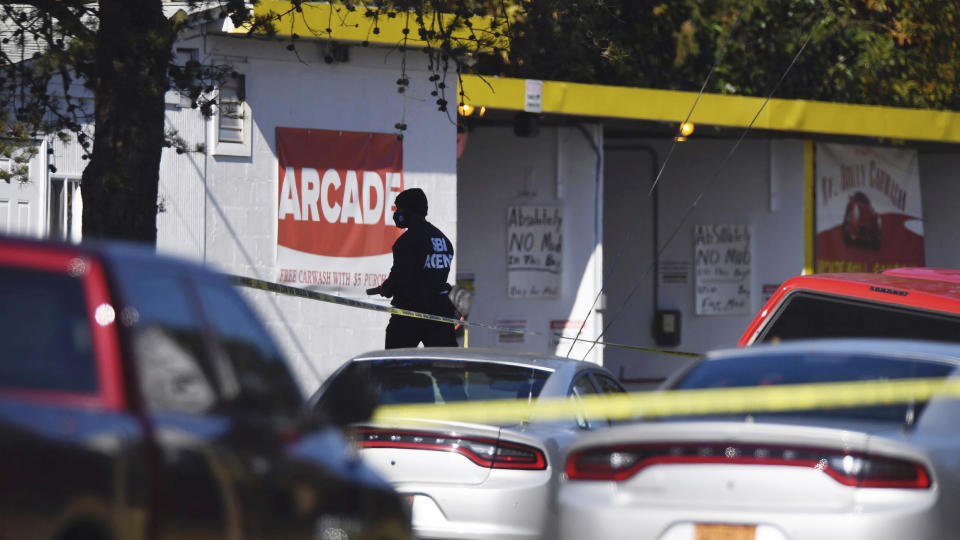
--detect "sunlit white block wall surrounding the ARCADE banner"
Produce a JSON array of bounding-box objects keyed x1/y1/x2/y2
[{"x1": 157, "y1": 36, "x2": 457, "y2": 392}]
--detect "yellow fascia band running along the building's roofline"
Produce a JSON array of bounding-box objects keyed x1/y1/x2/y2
[{"x1": 244, "y1": 0, "x2": 960, "y2": 143}]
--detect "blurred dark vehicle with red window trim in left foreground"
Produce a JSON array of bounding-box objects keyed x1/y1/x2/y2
[{"x1": 0, "y1": 238, "x2": 411, "y2": 540}]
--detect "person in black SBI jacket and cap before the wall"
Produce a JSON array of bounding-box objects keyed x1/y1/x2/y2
[{"x1": 372, "y1": 188, "x2": 457, "y2": 349}]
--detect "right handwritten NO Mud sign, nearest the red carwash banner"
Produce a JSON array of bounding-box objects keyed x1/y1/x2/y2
[{"x1": 693, "y1": 225, "x2": 750, "y2": 315}]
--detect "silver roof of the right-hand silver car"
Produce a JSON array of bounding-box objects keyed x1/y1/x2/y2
[{"x1": 704, "y1": 338, "x2": 960, "y2": 366}]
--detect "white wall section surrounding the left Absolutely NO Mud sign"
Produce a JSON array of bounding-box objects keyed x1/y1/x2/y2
[{"x1": 457, "y1": 124, "x2": 603, "y2": 363}]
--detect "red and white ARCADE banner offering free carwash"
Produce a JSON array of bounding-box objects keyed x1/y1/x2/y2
[{"x1": 277, "y1": 128, "x2": 403, "y2": 295}]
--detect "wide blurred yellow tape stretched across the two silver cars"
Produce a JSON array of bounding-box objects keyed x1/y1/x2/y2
[{"x1": 373, "y1": 378, "x2": 960, "y2": 424}]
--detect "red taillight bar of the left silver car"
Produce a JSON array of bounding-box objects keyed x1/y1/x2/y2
[{"x1": 354, "y1": 429, "x2": 547, "y2": 470}]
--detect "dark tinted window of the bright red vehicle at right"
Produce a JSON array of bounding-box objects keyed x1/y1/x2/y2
[{"x1": 757, "y1": 292, "x2": 960, "y2": 343}]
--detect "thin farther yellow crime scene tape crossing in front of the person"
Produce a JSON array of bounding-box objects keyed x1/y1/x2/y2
[{"x1": 227, "y1": 275, "x2": 700, "y2": 358}]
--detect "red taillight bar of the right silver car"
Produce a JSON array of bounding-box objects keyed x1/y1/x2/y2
[{"x1": 566, "y1": 443, "x2": 930, "y2": 489}]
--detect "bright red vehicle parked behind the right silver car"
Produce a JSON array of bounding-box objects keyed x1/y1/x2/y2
[{"x1": 739, "y1": 268, "x2": 960, "y2": 346}]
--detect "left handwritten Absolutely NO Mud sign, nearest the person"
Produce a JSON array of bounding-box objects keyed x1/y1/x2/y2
[{"x1": 507, "y1": 206, "x2": 563, "y2": 299}]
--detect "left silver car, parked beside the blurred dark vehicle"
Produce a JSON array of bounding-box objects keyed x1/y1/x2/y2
[{"x1": 312, "y1": 348, "x2": 623, "y2": 539}]
